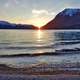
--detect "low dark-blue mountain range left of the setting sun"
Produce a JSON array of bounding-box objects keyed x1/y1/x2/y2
[{"x1": 0, "y1": 21, "x2": 37, "y2": 29}]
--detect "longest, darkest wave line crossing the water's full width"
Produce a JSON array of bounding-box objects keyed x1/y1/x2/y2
[{"x1": 0, "y1": 48, "x2": 80, "y2": 58}]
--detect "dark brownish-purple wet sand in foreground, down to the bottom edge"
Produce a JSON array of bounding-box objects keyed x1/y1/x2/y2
[{"x1": 0, "y1": 64, "x2": 80, "y2": 80}]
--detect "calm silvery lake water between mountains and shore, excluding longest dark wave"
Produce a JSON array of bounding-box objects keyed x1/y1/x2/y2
[{"x1": 0, "y1": 30, "x2": 80, "y2": 65}]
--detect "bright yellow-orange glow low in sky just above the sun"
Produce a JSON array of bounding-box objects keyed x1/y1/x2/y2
[{"x1": 10, "y1": 18, "x2": 49, "y2": 28}]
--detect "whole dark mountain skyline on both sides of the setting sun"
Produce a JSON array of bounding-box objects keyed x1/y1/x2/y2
[{"x1": 0, "y1": 8, "x2": 80, "y2": 30}]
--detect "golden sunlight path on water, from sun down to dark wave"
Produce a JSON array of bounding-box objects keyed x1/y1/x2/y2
[{"x1": 35, "y1": 29, "x2": 53, "y2": 53}]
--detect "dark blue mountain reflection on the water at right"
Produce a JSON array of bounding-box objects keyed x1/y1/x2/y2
[{"x1": 55, "y1": 31, "x2": 80, "y2": 41}]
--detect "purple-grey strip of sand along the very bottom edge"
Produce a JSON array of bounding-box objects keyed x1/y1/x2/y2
[{"x1": 0, "y1": 75, "x2": 80, "y2": 80}]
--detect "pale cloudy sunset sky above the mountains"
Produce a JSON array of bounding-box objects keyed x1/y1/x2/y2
[{"x1": 0, "y1": 0, "x2": 80, "y2": 27}]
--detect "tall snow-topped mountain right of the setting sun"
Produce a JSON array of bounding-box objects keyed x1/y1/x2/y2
[{"x1": 42, "y1": 8, "x2": 80, "y2": 29}]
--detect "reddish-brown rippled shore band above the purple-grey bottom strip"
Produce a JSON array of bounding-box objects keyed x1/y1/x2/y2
[{"x1": 0, "y1": 63, "x2": 80, "y2": 75}]
